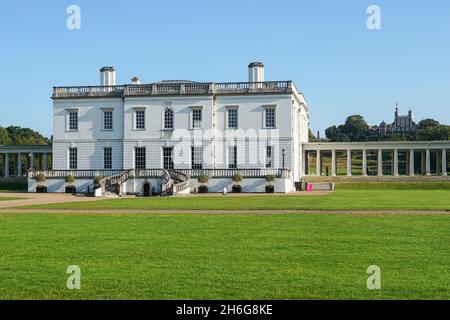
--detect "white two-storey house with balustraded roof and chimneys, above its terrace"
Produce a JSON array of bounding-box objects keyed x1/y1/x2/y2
[{"x1": 47, "y1": 62, "x2": 309, "y2": 192}]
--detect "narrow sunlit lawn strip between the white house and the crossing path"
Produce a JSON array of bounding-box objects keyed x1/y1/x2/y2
[{"x1": 24, "y1": 183, "x2": 450, "y2": 210}]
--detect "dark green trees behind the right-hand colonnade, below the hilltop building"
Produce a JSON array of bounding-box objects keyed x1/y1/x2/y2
[{"x1": 325, "y1": 115, "x2": 450, "y2": 142}]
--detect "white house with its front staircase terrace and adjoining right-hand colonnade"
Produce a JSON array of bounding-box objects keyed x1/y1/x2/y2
[{"x1": 21, "y1": 62, "x2": 450, "y2": 194}]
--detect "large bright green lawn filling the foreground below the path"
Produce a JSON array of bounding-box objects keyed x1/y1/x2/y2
[{"x1": 0, "y1": 214, "x2": 450, "y2": 299}]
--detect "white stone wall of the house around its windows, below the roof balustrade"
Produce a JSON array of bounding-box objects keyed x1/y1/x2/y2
[{"x1": 53, "y1": 87, "x2": 309, "y2": 181}]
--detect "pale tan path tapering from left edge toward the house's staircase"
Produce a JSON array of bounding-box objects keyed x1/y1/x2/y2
[{"x1": 0, "y1": 193, "x2": 101, "y2": 210}]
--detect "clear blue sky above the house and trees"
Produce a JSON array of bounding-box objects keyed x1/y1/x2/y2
[{"x1": 0, "y1": 0, "x2": 450, "y2": 136}]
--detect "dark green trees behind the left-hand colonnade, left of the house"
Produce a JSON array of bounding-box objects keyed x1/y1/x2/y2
[{"x1": 0, "y1": 126, "x2": 51, "y2": 146}]
